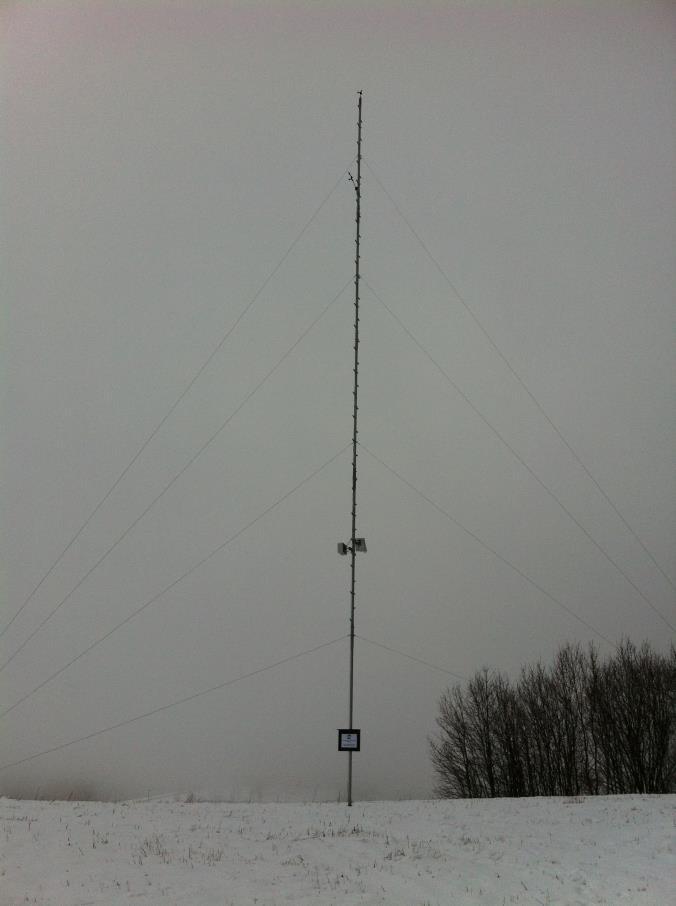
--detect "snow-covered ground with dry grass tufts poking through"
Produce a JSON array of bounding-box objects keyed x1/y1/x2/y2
[{"x1": 0, "y1": 796, "x2": 676, "y2": 906}]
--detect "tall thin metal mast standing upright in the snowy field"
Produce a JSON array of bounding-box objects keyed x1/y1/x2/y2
[{"x1": 347, "y1": 91, "x2": 362, "y2": 805}]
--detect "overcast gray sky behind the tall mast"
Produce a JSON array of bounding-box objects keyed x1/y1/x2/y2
[{"x1": 0, "y1": 0, "x2": 676, "y2": 798}]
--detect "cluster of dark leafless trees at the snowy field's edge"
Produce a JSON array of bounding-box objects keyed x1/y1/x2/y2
[{"x1": 430, "y1": 641, "x2": 676, "y2": 798}]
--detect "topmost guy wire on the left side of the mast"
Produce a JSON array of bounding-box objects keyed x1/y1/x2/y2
[{"x1": 0, "y1": 166, "x2": 349, "y2": 638}]
